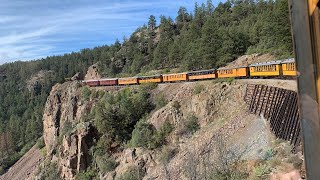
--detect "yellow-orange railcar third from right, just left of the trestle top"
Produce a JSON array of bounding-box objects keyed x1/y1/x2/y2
[{"x1": 217, "y1": 67, "x2": 249, "y2": 78}]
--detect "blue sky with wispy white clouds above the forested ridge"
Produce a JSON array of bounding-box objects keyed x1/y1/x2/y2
[{"x1": 0, "y1": 0, "x2": 225, "y2": 64}]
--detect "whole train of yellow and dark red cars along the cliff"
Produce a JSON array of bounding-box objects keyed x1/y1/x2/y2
[{"x1": 82, "y1": 58, "x2": 297, "y2": 87}]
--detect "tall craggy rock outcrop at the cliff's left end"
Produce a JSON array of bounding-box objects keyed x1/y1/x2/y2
[{"x1": 43, "y1": 81, "x2": 95, "y2": 179}]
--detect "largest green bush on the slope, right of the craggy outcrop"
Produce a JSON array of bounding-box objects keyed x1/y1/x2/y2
[{"x1": 92, "y1": 88, "x2": 154, "y2": 142}]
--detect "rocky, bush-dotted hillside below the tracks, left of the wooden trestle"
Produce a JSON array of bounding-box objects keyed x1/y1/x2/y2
[{"x1": 16, "y1": 80, "x2": 301, "y2": 179}]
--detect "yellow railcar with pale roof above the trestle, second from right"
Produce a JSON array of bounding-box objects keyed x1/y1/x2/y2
[{"x1": 249, "y1": 61, "x2": 281, "y2": 77}]
